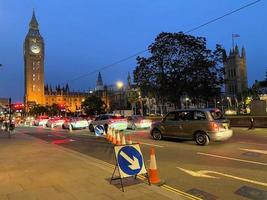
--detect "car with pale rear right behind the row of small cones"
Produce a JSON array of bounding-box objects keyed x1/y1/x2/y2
[{"x1": 89, "y1": 114, "x2": 128, "y2": 132}]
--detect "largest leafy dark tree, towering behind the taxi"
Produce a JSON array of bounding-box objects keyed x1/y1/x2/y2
[{"x1": 134, "y1": 32, "x2": 225, "y2": 107}]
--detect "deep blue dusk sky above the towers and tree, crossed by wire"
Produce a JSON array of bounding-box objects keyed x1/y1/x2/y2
[{"x1": 0, "y1": 0, "x2": 267, "y2": 101}]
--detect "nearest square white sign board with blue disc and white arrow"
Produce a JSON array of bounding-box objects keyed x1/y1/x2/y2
[{"x1": 114, "y1": 144, "x2": 147, "y2": 178}]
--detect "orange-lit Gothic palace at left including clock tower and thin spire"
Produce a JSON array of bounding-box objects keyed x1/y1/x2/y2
[{"x1": 24, "y1": 11, "x2": 109, "y2": 112}]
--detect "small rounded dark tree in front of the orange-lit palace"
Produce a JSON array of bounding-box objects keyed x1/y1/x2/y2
[{"x1": 82, "y1": 95, "x2": 107, "y2": 115}]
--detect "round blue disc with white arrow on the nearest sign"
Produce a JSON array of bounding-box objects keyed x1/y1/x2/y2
[{"x1": 117, "y1": 146, "x2": 144, "y2": 176}]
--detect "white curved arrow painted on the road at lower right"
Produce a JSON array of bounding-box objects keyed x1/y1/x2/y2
[{"x1": 176, "y1": 167, "x2": 267, "y2": 187}]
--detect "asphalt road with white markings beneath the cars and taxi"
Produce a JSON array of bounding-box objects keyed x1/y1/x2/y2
[{"x1": 17, "y1": 127, "x2": 267, "y2": 200}]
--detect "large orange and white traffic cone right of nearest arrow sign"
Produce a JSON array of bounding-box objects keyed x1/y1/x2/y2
[{"x1": 149, "y1": 147, "x2": 164, "y2": 185}]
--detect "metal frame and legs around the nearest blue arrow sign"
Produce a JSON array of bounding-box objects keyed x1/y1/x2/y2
[{"x1": 110, "y1": 143, "x2": 151, "y2": 192}]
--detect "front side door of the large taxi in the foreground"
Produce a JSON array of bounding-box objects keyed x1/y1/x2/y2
[{"x1": 163, "y1": 111, "x2": 182, "y2": 137}]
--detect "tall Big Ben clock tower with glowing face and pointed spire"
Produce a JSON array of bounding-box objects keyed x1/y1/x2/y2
[{"x1": 24, "y1": 11, "x2": 45, "y2": 110}]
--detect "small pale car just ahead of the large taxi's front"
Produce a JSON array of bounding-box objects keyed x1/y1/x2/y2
[{"x1": 127, "y1": 115, "x2": 152, "y2": 130}]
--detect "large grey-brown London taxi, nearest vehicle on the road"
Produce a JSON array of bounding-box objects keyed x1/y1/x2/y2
[{"x1": 150, "y1": 108, "x2": 233, "y2": 145}]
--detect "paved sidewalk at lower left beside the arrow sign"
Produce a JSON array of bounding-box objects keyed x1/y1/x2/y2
[{"x1": 0, "y1": 132, "x2": 184, "y2": 200}]
